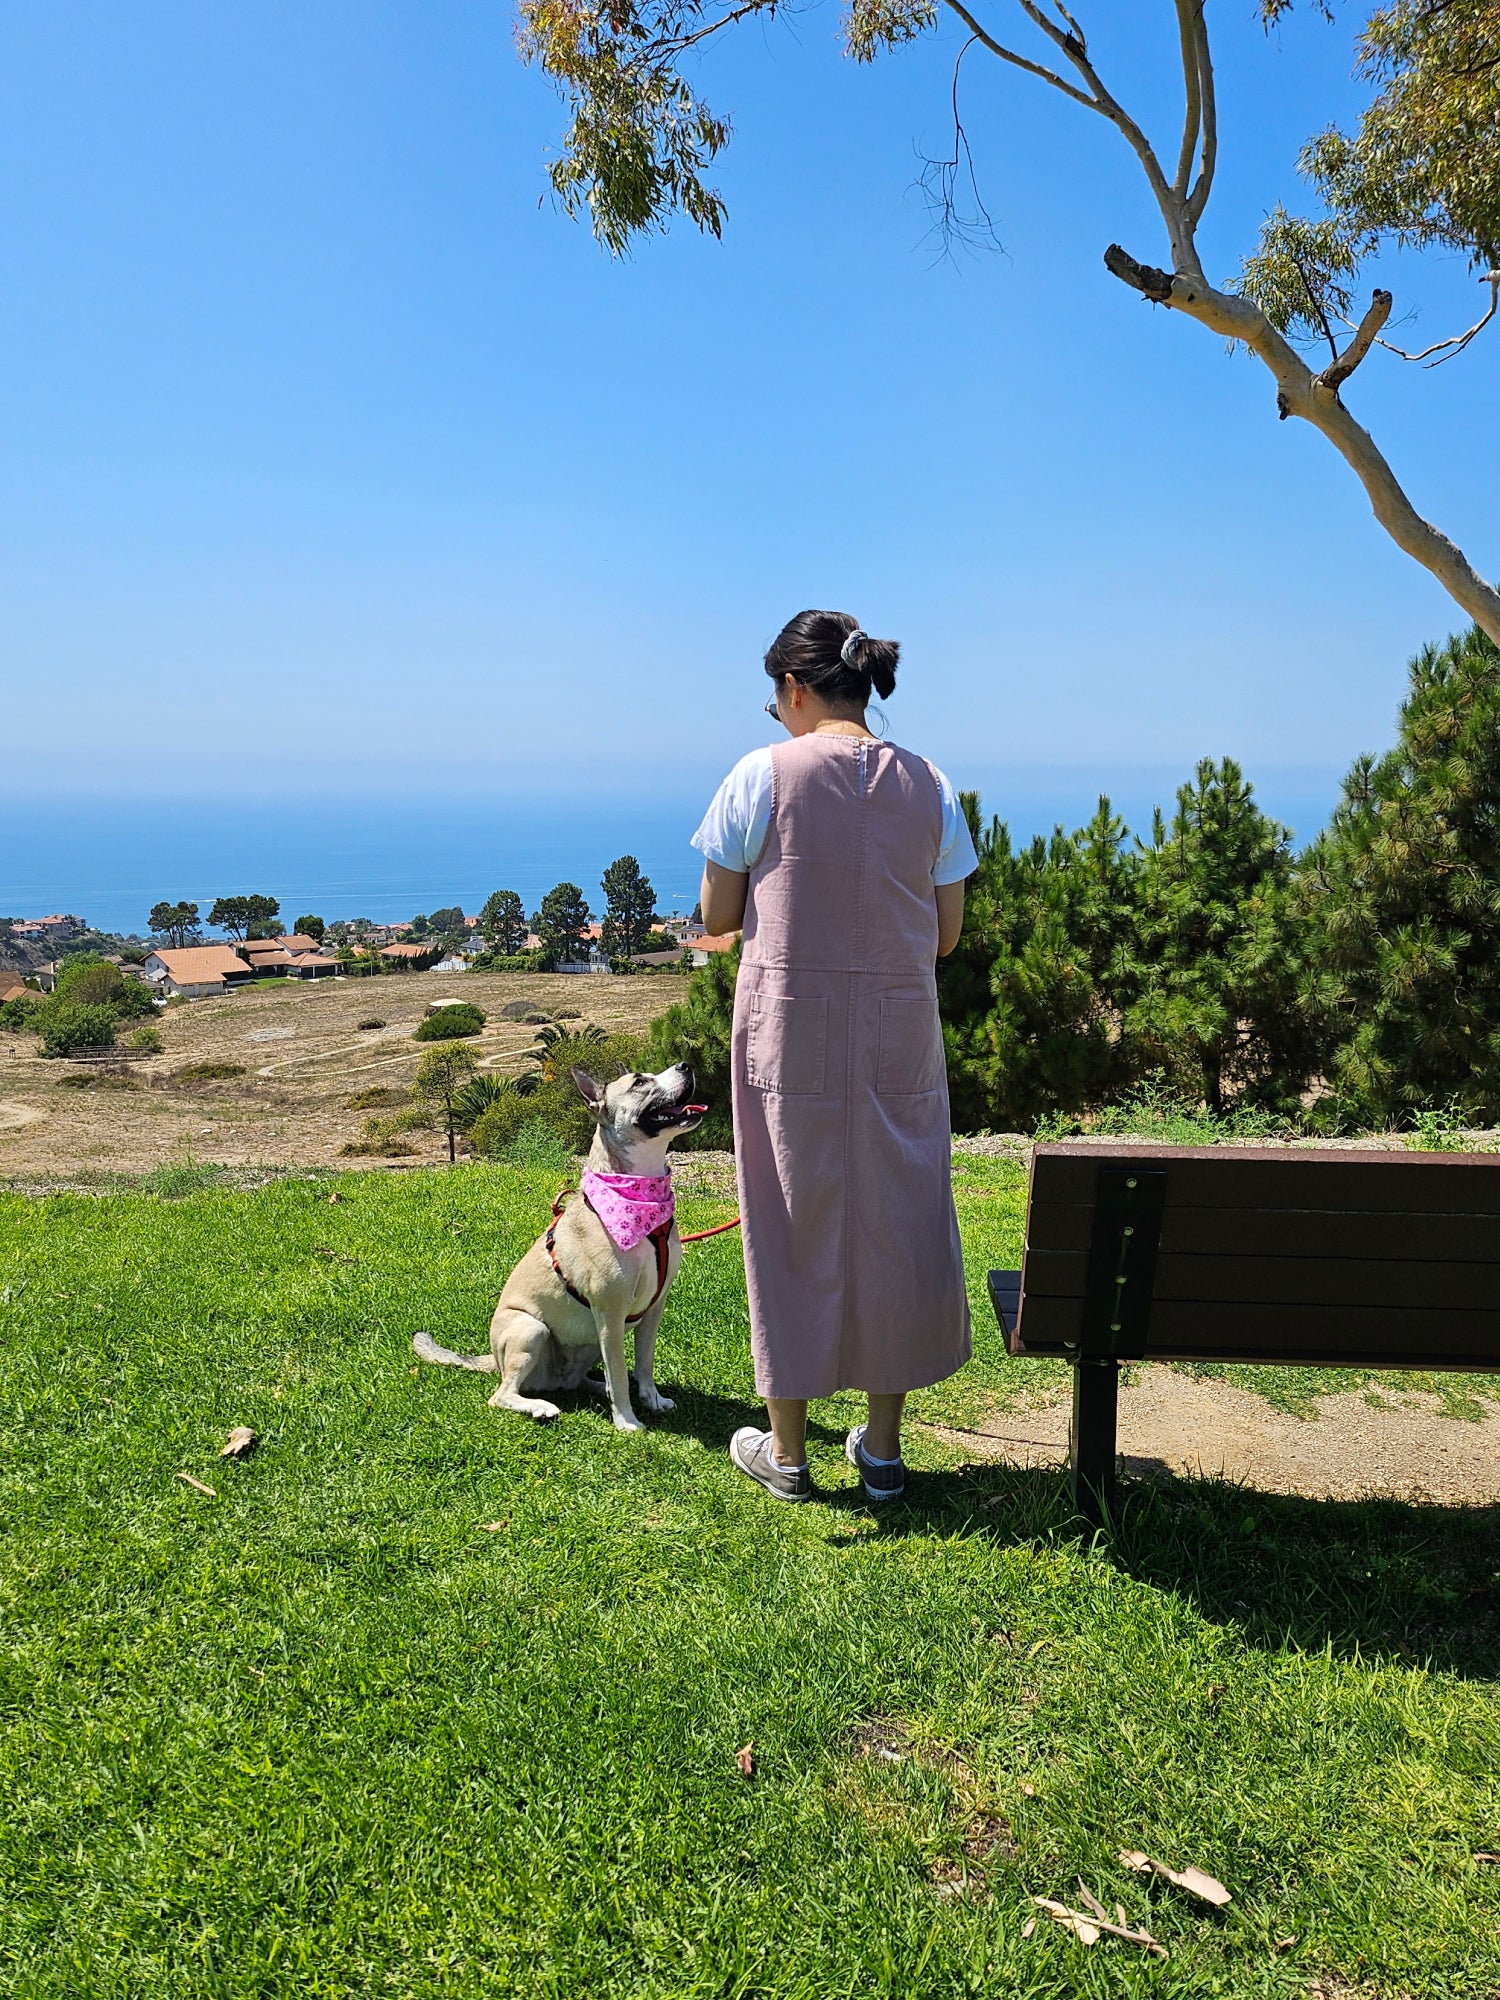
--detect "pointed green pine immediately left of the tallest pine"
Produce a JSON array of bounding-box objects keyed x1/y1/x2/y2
[{"x1": 1120, "y1": 758, "x2": 1314, "y2": 1114}]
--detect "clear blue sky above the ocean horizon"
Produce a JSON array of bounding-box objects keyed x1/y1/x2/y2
[{"x1": 0, "y1": 0, "x2": 1500, "y2": 860}]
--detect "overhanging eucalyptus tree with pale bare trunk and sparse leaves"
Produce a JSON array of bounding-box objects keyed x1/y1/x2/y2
[{"x1": 520, "y1": 0, "x2": 1500, "y2": 644}]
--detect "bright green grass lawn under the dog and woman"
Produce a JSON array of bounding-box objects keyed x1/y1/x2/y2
[{"x1": 0, "y1": 1160, "x2": 1500, "y2": 2000}]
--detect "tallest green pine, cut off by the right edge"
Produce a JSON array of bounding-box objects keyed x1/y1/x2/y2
[{"x1": 1300, "y1": 626, "x2": 1500, "y2": 1126}]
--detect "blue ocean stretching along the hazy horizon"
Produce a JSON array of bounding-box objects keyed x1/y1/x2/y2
[{"x1": 0, "y1": 768, "x2": 1336, "y2": 934}]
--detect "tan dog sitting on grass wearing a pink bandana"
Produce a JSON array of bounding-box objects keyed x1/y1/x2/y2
[{"x1": 412, "y1": 1062, "x2": 708, "y2": 1430}]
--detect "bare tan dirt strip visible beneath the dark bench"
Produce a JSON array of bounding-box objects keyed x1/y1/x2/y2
[{"x1": 932, "y1": 1366, "x2": 1500, "y2": 1506}]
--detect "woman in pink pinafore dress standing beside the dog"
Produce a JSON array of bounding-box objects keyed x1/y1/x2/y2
[{"x1": 692, "y1": 612, "x2": 978, "y2": 1500}]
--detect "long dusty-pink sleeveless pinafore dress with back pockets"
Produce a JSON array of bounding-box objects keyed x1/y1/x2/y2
[{"x1": 734, "y1": 734, "x2": 970, "y2": 1398}]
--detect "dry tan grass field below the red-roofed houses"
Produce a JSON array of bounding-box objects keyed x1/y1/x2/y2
[{"x1": 0, "y1": 972, "x2": 684, "y2": 1180}]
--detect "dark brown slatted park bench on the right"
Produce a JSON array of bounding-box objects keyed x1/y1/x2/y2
[{"x1": 990, "y1": 1142, "x2": 1500, "y2": 1520}]
